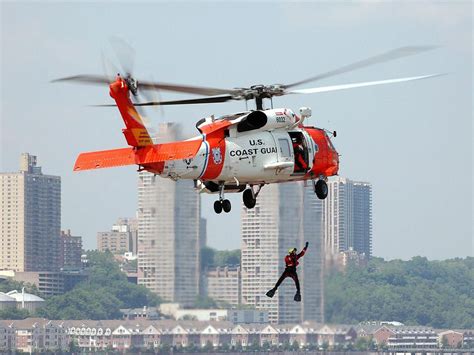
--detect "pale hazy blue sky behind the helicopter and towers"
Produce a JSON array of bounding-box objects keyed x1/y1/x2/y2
[{"x1": 0, "y1": 1, "x2": 474, "y2": 259}]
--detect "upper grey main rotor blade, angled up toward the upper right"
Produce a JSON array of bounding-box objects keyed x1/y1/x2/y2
[{"x1": 282, "y1": 46, "x2": 437, "y2": 89}]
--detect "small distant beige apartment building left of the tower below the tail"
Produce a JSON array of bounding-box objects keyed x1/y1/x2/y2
[{"x1": 97, "y1": 218, "x2": 138, "y2": 255}]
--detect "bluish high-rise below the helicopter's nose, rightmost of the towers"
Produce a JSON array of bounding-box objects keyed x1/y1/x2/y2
[{"x1": 323, "y1": 177, "x2": 372, "y2": 259}]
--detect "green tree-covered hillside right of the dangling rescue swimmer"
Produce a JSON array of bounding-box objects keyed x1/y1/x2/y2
[{"x1": 325, "y1": 257, "x2": 474, "y2": 328}]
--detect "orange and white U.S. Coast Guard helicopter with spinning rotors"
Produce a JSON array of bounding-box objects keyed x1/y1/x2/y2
[{"x1": 54, "y1": 46, "x2": 439, "y2": 213}]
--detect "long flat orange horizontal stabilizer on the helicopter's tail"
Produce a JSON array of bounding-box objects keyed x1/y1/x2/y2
[{"x1": 74, "y1": 139, "x2": 202, "y2": 171}]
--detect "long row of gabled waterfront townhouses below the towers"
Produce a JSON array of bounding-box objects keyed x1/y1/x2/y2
[{"x1": 0, "y1": 318, "x2": 357, "y2": 352}]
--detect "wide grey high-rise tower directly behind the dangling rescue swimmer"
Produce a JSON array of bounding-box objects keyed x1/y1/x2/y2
[{"x1": 241, "y1": 182, "x2": 324, "y2": 323}]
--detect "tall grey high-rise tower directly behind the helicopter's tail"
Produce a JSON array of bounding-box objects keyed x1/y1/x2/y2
[{"x1": 138, "y1": 124, "x2": 203, "y2": 306}]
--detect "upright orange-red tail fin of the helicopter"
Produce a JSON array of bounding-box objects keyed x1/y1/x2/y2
[{"x1": 110, "y1": 77, "x2": 153, "y2": 147}]
